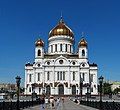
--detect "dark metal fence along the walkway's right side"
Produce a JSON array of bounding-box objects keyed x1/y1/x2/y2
[{"x1": 80, "y1": 101, "x2": 120, "y2": 110}]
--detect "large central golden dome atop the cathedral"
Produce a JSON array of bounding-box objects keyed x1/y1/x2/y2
[{"x1": 49, "y1": 17, "x2": 74, "y2": 38}]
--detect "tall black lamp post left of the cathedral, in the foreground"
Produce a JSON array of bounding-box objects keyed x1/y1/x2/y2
[{"x1": 15, "y1": 76, "x2": 21, "y2": 110}]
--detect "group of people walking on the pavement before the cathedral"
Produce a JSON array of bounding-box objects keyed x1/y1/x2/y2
[{"x1": 40, "y1": 96, "x2": 64, "y2": 110}]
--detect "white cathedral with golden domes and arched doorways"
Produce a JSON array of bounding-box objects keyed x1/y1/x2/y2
[{"x1": 25, "y1": 17, "x2": 98, "y2": 95}]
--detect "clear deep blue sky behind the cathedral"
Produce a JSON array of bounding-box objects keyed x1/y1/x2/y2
[{"x1": 0, "y1": 0, "x2": 120, "y2": 84}]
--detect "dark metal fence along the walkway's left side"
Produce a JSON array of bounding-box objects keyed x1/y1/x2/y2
[{"x1": 0, "y1": 100, "x2": 40, "y2": 110}]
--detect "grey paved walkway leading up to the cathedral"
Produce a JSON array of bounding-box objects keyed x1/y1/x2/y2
[{"x1": 24, "y1": 98, "x2": 98, "y2": 110}]
